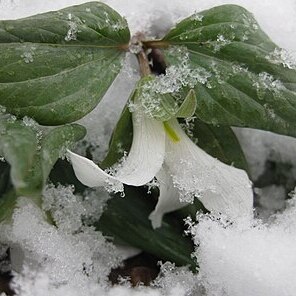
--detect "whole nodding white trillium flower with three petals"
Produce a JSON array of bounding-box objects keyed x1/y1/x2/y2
[{"x1": 69, "y1": 106, "x2": 253, "y2": 228}]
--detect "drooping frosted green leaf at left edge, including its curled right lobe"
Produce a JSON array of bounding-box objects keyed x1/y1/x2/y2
[{"x1": 0, "y1": 116, "x2": 85, "y2": 195}]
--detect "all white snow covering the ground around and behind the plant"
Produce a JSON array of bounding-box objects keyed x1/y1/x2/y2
[{"x1": 0, "y1": 0, "x2": 296, "y2": 296}]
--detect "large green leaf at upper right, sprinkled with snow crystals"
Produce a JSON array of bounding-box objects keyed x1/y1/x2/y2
[{"x1": 163, "y1": 5, "x2": 296, "y2": 136}]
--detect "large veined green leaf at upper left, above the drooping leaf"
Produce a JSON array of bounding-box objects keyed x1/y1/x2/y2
[{"x1": 0, "y1": 2, "x2": 130, "y2": 125}]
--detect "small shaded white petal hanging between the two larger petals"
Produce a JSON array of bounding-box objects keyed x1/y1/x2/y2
[{"x1": 149, "y1": 167, "x2": 187, "y2": 229}]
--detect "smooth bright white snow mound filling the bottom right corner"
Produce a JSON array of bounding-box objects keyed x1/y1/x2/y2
[{"x1": 193, "y1": 199, "x2": 296, "y2": 296}]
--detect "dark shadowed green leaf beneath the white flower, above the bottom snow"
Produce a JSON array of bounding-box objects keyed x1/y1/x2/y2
[{"x1": 96, "y1": 187, "x2": 196, "y2": 269}]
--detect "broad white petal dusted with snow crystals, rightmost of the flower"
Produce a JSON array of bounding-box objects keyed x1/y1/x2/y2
[{"x1": 165, "y1": 120, "x2": 253, "y2": 219}]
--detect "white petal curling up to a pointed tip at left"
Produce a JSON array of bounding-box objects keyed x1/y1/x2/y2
[{"x1": 69, "y1": 112, "x2": 165, "y2": 187}]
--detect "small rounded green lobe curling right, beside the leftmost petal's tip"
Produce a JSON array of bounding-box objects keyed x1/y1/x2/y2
[{"x1": 40, "y1": 124, "x2": 86, "y2": 184}]
